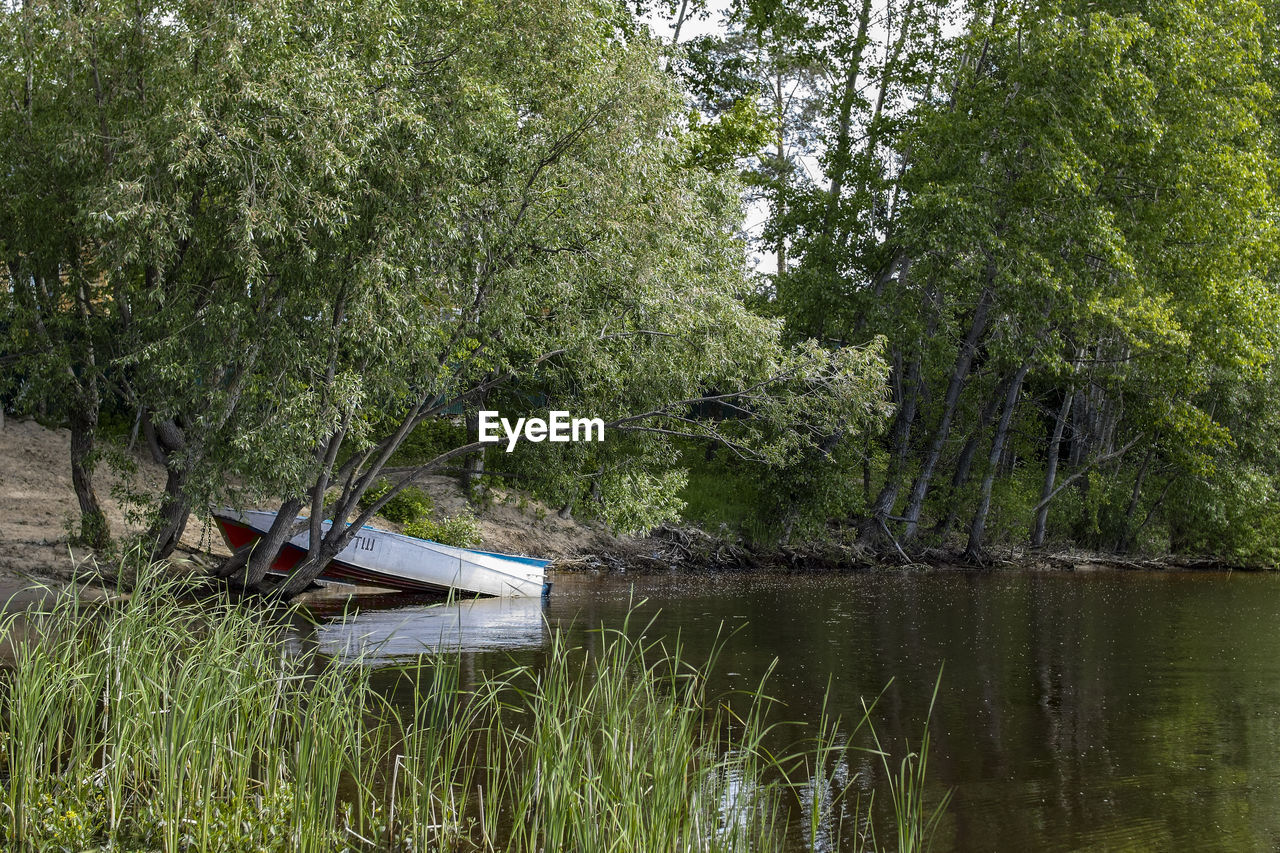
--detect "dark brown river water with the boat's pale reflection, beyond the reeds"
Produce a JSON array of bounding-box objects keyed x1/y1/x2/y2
[{"x1": 314, "y1": 563, "x2": 1280, "y2": 852}]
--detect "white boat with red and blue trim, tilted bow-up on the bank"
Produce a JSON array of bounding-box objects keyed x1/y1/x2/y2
[{"x1": 214, "y1": 508, "x2": 550, "y2": 598}]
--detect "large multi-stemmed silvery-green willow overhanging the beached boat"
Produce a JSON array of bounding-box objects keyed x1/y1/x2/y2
[{"x1": 3, "y1": 0, "x2": 881, "y2": 594}]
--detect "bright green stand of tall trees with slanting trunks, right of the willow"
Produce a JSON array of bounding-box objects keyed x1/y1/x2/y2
[{"x1": 701, "y1": 0, "x2": 1280, "y2": 560}]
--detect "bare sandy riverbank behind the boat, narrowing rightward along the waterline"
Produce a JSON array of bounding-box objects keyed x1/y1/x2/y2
[{"x1": 0, "y1": 420, "x2": 1248, "y2": 597}]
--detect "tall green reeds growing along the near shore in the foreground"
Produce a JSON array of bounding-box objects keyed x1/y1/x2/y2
[{"x1": 0, "y1": 560, "x2": 942, "y2": 853}]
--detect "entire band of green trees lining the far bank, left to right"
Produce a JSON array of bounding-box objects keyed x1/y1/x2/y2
[{"x1": 10, "y1": 0, "x2": 1280, "y2": 562}]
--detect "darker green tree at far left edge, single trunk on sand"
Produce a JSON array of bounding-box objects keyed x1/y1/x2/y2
[{"x1": 0, "y1": 3, "x2": 147, "y2": 546}]
